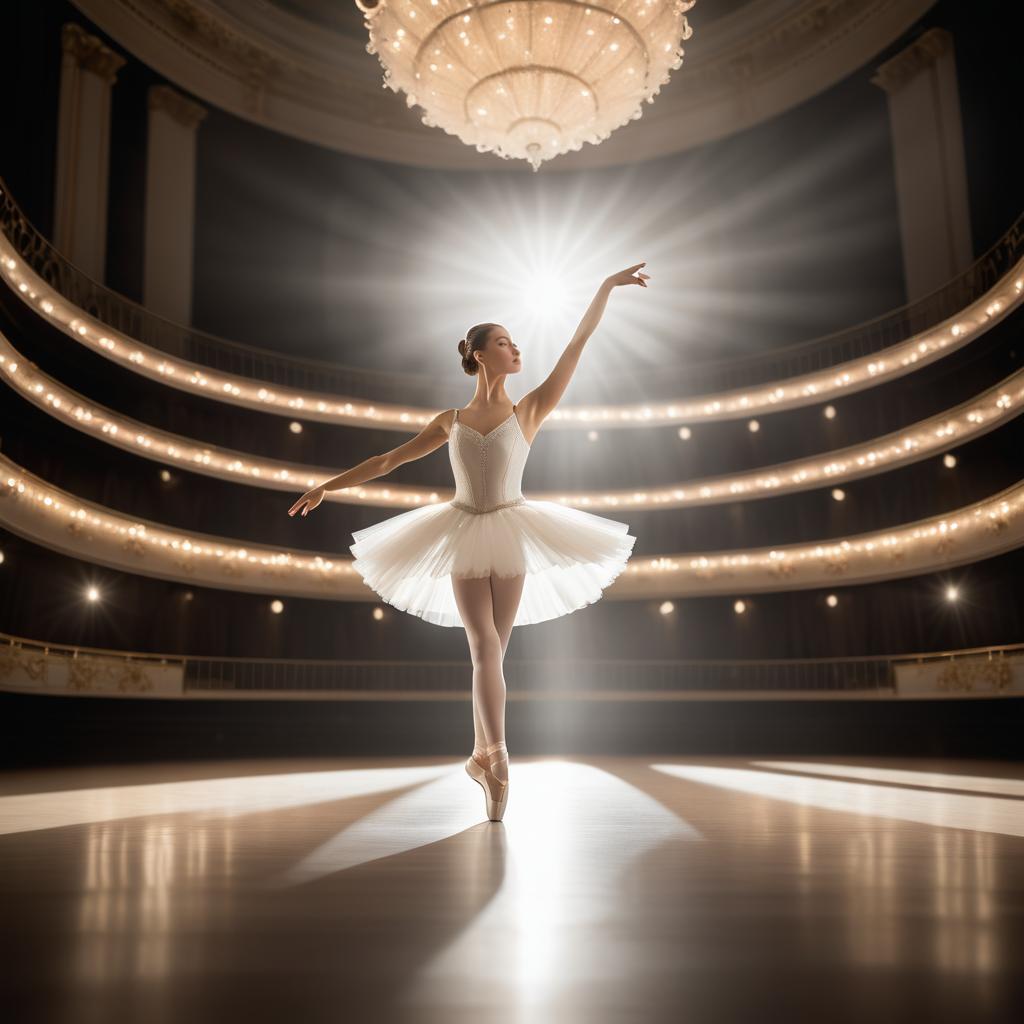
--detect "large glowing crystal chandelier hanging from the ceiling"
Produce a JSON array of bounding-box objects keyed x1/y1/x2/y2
[{"x1": 355, "y1": 0, "x2": 696, "y2": 171}]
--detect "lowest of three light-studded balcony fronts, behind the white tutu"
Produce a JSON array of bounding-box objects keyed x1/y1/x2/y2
[{"x1": 0, "y1": 455, "x2": 1024, "y2": 600}]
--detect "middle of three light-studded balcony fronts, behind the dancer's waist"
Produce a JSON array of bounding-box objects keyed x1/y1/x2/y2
[{"x1": 0, "y1": 332, "x2": 1024, "y2": 510}]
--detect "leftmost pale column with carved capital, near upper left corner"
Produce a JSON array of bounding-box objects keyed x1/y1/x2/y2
[{"x1": 53, "y1": 23, "x2": 125, "y2": 282}]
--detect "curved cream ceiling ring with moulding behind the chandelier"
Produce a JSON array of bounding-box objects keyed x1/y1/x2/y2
[{"x1": 73, "y1": 0, "x2": 935, "y2": 173}]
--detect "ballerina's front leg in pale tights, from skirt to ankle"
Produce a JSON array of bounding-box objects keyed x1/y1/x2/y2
[{"x1": 452, "y1": 577, "x2": 505, "y2": 770}]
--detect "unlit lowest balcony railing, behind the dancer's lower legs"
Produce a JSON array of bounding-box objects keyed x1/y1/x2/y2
[{"x1": 0, "y1": 633, "x2": 1024, "y2": 700}]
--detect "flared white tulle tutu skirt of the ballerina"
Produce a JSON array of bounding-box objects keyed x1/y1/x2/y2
[{"x1": 349, "y1": 499, "x2": 636, "y2": 626}]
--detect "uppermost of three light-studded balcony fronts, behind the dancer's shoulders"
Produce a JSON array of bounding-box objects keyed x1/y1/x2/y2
[{"x1": 0, "y1": 234, "x2": 1024, "y2": 431}]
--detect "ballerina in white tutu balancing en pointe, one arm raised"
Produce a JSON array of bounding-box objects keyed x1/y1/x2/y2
[{"x1": 288, "y1": 263, "x2": 650, "y2": 821}]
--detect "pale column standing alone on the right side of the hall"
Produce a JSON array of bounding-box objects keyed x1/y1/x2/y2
[{"x1": 871, "y1": 29, "x2": 973, "y2": 302}]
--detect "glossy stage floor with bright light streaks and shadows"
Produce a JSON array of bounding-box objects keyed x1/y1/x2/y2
[{"x1": 0, "y1": 754, "x2": 1024, "y2": 1024}]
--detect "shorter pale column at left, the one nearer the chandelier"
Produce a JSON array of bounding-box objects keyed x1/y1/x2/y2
[{"x1": 142, "y1": 85, "x2": 206, "y2": 324}]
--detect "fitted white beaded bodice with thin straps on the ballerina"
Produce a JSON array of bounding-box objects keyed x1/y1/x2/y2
[{"x1": 449, "y1": 406, "x2": 529, "y2": 512}]
